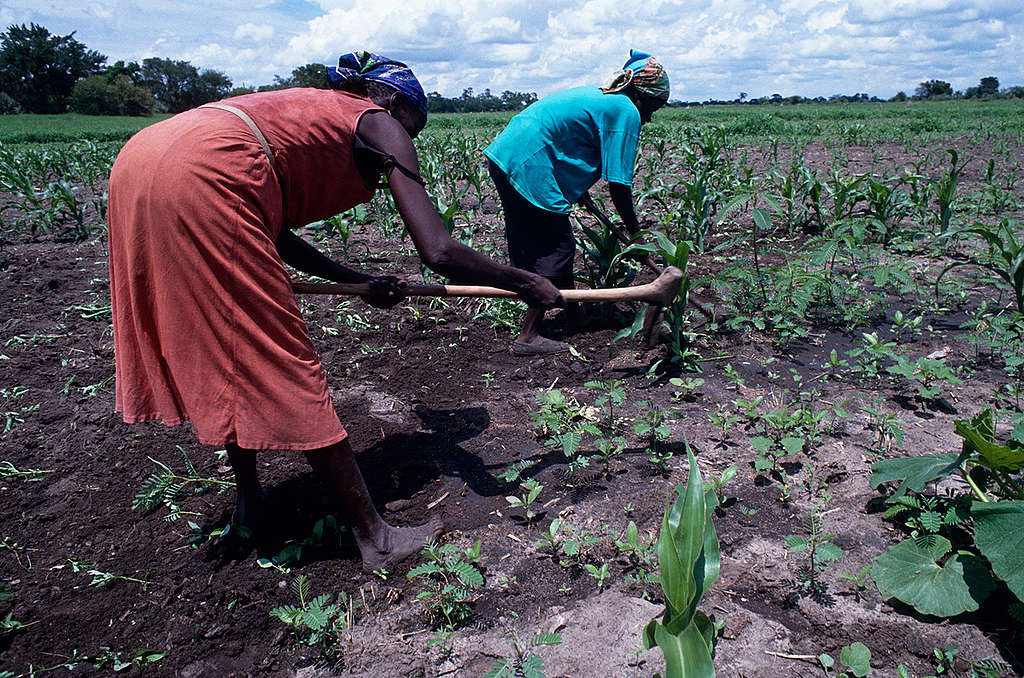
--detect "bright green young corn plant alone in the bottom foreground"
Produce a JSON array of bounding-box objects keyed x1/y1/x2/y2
[{"x1": 643, "y1": 450, "x2": 721, "y2": 678}]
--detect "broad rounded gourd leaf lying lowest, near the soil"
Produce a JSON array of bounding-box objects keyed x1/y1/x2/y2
[{"x1": 871, "y1": 535, "x2": 994, "y2": 617}]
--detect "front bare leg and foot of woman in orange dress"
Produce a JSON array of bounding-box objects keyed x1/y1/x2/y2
[{"x1": 305, "y1": 439, "x2": 441, "y2": 571}]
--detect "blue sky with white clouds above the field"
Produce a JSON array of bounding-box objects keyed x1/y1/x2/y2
[{"x1": 0, "y1": 0, "x2": 1024, "y2": 100}]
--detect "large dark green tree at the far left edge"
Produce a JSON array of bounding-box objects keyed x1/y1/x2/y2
[{"x1": 0, "y1": 24, "x2": 106, "y2": 113}]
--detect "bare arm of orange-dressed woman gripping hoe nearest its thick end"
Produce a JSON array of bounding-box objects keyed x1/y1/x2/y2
[{"x1": 358, "y1": 113, "x2": 564, "y2": 306}]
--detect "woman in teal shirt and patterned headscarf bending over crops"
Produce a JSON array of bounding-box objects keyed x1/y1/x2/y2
[{"x1": 483, "y1": 50, "x2": 669, "y2": 354}]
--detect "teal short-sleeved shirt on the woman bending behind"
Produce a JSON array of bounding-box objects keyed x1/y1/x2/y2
[{"x1": 483, "y1": 87, "x2": 640, "y2": 213}]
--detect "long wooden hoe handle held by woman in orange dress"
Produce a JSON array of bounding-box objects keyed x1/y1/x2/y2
[{"x1": 292, "y1": 266, "x2": 683, "y2": 306}]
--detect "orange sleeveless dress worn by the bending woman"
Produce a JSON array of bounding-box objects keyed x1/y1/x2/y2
[{"x1": 109, "y1": 89, "x2": 381, "y2": 450}]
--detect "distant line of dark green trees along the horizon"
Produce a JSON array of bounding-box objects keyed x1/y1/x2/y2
[{"x1": 0, "y1": 24, "x2": 1024, "y2": 116}]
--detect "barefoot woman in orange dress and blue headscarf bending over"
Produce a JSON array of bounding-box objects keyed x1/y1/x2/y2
[{"x1": 109, "y1": 52, "x2": 563, "y2": 570}]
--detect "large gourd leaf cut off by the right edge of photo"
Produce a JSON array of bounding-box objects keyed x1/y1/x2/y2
[{"x1": 971, "y1": 502, "x2": 1024, "y2": 600}]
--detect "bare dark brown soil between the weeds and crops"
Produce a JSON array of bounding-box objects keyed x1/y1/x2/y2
[{"x1": 0, "y1": 135, "x2": 1024, "y2": 677}]
